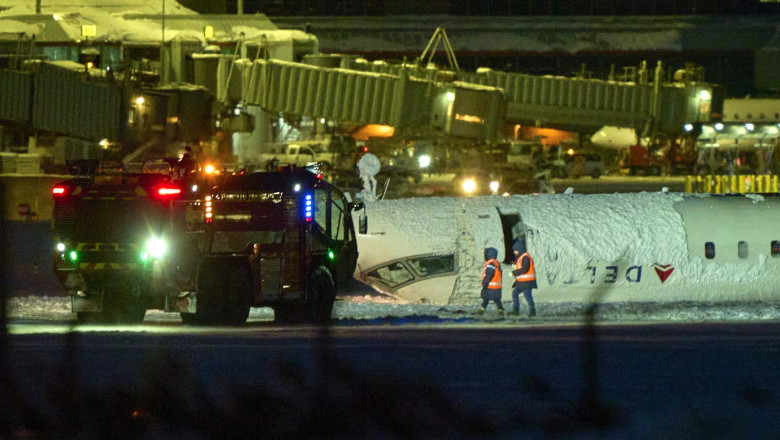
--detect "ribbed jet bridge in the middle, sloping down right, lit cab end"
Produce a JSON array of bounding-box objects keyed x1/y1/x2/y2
[{"x1": 194, "y1": 56, "x2": 506, "y2": 142}]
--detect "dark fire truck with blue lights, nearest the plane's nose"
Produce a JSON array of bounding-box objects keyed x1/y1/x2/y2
[{"x1": 171, "y1": 168, "x2": 360, "y2": 325}]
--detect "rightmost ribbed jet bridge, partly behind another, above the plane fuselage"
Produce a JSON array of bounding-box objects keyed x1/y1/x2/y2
[{"x1": 350, "y1": 62, "x2": 712, "y2": 133}]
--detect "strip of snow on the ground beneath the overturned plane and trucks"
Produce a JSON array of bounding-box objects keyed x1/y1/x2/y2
[{"x1": 8, "y1": 292, "x2": 780, "y2": 326}]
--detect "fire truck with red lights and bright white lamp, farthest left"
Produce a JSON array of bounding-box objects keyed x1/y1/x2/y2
[{"x1": 52, "y1": 159, "x2": 217, "y2": 323}]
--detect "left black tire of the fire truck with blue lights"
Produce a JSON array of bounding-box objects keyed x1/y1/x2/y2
[{"x1": 186, "y1": 259, "x2": 252, "y2": 326}]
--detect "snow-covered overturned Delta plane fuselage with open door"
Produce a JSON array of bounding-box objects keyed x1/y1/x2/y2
[{"x1": 355, "y1": 192, "x2": 780, "y2": 304}]
